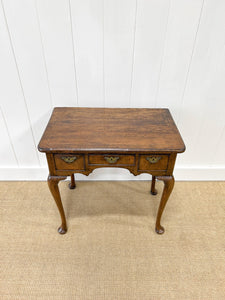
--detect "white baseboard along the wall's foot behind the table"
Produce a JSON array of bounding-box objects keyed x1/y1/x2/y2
[{"x1": 0, "y1": 165, "x2": 225, "y2": 181}]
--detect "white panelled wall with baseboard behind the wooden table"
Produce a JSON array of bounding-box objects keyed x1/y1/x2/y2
[{"x1": 0, "y1": 0, "x2": 225, "y2": 180}]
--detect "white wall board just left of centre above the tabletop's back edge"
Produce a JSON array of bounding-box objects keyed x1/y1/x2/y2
[{"x1": 70, "y1": 0, "x2": 104, "y2": 106}]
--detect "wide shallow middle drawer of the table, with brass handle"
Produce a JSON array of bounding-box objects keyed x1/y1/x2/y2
[{"x1": 88, "y1": 154, "x2": 135, "y2": 166}]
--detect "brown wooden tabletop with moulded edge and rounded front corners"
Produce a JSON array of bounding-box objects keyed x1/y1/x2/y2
[{"x1": 38, "y1": 107, "x2": 185, "y2": 153}]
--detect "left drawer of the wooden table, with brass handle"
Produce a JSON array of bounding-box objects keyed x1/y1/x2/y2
[{"x1": 54, "y1": 154, "x2": 85, "y2": 170}]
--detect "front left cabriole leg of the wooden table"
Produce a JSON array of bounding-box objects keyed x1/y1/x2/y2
[{"x1": 48, "y1": 175, "x2": 67, "y2": 234}]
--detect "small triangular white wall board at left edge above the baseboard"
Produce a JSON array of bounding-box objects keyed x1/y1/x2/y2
[{"x1": 0, "y1": 110, "x2": 17, "y2": 167}]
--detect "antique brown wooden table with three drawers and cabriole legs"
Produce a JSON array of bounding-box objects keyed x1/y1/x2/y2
[{"x1": 38, "y1": 107, "x2": 185, "y2": 234}]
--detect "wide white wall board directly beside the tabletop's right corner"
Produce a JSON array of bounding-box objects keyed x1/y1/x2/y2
[{"x1": 179, "y1": 0, "x2": 225, "y2": 165}]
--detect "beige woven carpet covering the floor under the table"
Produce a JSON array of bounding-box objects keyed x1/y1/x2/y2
[{"x1": 0, "y1": 181, "x2": 225, "y2": 300}]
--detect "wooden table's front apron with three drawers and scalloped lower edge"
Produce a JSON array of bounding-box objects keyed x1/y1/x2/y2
[{"x1": 46, "y1": 153, "x2": 177, "y2": 176}]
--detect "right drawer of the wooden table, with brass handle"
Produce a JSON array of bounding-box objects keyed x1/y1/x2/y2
[{"x1": 138, "y1": 154, "x2": 169, "y2": 171}]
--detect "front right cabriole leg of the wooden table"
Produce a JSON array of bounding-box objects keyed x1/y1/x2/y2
[{"x1": 155, "y1": 176, "x2": 175, "y2": 234}]
